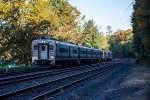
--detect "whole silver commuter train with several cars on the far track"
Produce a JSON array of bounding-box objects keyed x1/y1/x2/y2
[{"x1": 32, "y1": 37, "x2": 113, "y2": 66}]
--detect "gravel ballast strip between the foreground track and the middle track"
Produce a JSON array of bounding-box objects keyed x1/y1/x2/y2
[{"x1": 0, "y1": 64, "x2": 113, "y2": 98}]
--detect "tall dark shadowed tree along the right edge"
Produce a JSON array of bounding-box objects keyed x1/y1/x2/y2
[{"x1": 132, "y1": 0, "x2": 150, "y2": 62}]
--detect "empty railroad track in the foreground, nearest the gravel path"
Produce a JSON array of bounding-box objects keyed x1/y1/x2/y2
[{"x1": 0, "y1": 63, "x2": 119, "y2": 100}]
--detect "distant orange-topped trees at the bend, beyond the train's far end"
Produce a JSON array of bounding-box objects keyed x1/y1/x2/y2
[{"x1": 109, "y1": 29, "x2": 134, "y2": 57}]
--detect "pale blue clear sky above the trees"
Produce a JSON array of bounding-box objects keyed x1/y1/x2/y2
[{"x1": 69, "y1": 0, "x2": 133, "y2": 34}]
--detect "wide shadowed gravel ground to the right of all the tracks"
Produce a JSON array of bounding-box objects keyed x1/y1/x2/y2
[{"x1": 49, "y1": 59, "x2": 150, "y2": 100}]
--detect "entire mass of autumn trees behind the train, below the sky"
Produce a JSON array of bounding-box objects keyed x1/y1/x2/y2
[{"x1": 0, "y1": 0, "x2": 136, "y2": 64}]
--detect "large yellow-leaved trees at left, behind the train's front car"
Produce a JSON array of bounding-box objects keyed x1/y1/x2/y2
[{"x1": 0, "y1": 0, "x2": 81, "y2": 64}]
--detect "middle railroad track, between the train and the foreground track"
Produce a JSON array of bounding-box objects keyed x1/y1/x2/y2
[{"x1": 0, "y1": 64, "x2": 103, "y2": 86}]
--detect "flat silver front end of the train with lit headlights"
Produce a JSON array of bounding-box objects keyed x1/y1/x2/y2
[{"x1": 32, "y1": 39, "x2": 55, "y2": 66}]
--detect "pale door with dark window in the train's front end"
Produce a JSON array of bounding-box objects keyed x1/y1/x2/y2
[{"x1": 39, "y1": 44, "x2": 48, "y2": 59}]
